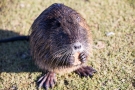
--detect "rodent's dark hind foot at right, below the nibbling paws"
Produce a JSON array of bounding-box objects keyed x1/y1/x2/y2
[{"x1": 74, "y1": 66, "x2": 97, "y2": 78}]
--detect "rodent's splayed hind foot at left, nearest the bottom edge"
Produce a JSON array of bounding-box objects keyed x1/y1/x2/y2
[{"x1": 37, "y1": 72, "x2": 56, "y2": 90}]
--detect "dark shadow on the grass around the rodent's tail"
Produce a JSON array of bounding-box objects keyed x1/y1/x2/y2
[{"x1": 0, "y1": 29, "x2": 39, "y2": 73}]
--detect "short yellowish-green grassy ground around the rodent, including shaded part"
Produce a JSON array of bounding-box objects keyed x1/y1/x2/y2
[{"x1": 0, "y1": 0, "x2": 135, "y2": 90}]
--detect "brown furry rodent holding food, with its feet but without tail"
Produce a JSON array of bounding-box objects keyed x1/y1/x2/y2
[{"x1": 30, "y1": 3, "x2": 96, "y2": 89}]
